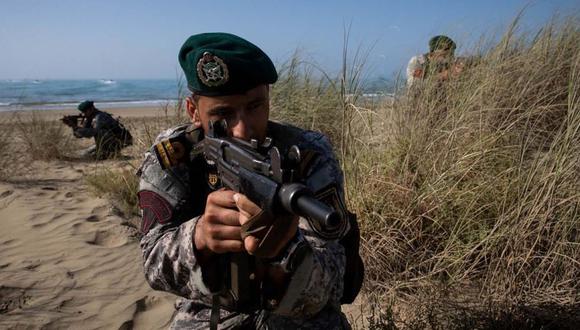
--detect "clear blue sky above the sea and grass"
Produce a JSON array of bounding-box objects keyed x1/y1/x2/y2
[{"x1": 0, "y1": 0, "x2": 580, "y2": 79}]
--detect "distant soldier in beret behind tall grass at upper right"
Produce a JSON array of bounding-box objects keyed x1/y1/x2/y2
[{"x1": 407, "y1": 35, "x2": 461, "y2": 87}]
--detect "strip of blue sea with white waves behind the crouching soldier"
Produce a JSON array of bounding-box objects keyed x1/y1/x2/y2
[{"x1": 0, "y1": 79, "x2": 185, "y2": 111}]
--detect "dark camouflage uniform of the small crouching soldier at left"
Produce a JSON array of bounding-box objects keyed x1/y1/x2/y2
[{"x1": 73, "y1": 109, "x2": 132, "y2": 159}]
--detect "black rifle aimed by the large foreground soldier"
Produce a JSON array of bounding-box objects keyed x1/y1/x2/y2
[{"x1": 202, "y1": 120, "x2": 341, "y2": 314}]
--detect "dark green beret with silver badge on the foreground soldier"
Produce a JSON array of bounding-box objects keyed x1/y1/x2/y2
[{"x1": 179, "y1": 33, "x2": 278, "y2": 96}]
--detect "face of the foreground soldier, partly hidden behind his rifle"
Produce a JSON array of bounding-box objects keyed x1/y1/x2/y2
[{"x1": 186, "y1": 85, "x2": 270, "y2": 142}]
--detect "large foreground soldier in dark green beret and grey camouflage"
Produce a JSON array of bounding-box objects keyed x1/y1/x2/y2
[{"x1": 138, "y1": 33, "x2": 364, "y2": 329}]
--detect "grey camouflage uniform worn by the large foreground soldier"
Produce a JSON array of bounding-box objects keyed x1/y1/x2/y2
[{"x1": 138, "y1": 122, "x2": 350, "y2": 329}]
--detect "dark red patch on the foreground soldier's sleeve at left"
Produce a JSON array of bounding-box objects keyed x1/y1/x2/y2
[{"x1": 138, "y1": 190, "x2": 173, "y2": 234}]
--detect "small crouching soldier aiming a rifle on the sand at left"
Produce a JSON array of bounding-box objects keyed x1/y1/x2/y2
[{"x1": 62, "y1": 101, "x2": 133, "y2": 160}]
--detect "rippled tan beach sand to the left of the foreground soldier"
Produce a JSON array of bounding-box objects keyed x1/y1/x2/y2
[{"x1": 0, "y1": 108, "x2": 358, "y2": 329}]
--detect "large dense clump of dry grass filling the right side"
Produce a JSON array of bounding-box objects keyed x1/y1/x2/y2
[{"x1": 347, "y1": 18, "x2": 580, "y2": 328}]
